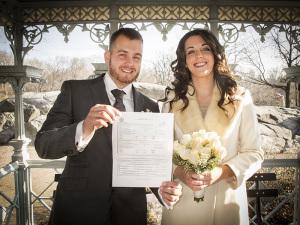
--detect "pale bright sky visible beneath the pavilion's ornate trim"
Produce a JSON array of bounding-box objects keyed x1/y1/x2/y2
[{"x1": 0, "y1": 26, "x2": 280, "y2": 75}]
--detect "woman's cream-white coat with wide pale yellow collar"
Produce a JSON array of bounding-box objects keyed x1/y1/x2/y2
[{"x1": 162, "y1": 85, "x2": 263, "y2": 225}]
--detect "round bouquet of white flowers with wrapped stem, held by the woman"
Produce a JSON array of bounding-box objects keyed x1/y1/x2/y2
[{"x1": 173, "y1": 130, "x2": 225, "y2": 202}]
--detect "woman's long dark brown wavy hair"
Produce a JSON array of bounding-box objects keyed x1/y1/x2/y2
[{"x1": 163, "y1": 29, "x2": 237, "y2": 111}]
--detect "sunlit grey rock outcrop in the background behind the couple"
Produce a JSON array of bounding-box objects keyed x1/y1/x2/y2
[{"x1": 0, "y1": 83, "x2": 300, "y2": 153}]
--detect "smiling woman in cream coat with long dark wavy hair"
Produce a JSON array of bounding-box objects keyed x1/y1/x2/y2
[{"x1": 162, "y1": 29, "x2": 263, "y2": 225}]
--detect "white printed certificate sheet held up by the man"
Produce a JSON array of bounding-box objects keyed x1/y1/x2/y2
[{"x1": 112, "y1": 112, "x2": 174, "y2": 187}]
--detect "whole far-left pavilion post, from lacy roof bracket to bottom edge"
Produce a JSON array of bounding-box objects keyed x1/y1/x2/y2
[{"x1": 0, "y1": 8, "x2": 35, "y2": 225}]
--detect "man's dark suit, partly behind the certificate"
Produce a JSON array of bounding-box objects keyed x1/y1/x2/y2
[{"x1": 35, "y1": 76, "x2": 159, "y2": 225}]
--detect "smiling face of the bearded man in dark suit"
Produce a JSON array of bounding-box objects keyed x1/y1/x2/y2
[{"x1": 104, "y1": 35, "x2": 143, "y2": 88}]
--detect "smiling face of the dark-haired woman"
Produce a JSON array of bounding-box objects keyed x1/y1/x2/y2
[{"x1": 184, "y1": 35, "x2": 215, "y2": 79}]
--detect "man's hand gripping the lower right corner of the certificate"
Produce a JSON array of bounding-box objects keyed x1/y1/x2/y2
[{"x1": 159, "y1": 181, "x2": 182, "y2": 207}]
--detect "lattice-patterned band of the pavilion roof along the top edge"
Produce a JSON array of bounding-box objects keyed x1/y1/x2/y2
[{"x1": 0, "y1": 0, "x2": 300, "y2": 25}]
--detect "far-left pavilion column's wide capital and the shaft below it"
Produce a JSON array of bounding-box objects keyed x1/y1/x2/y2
[{"x1": 0, "y1": 65, "x2": 41, "y2": 225}]
